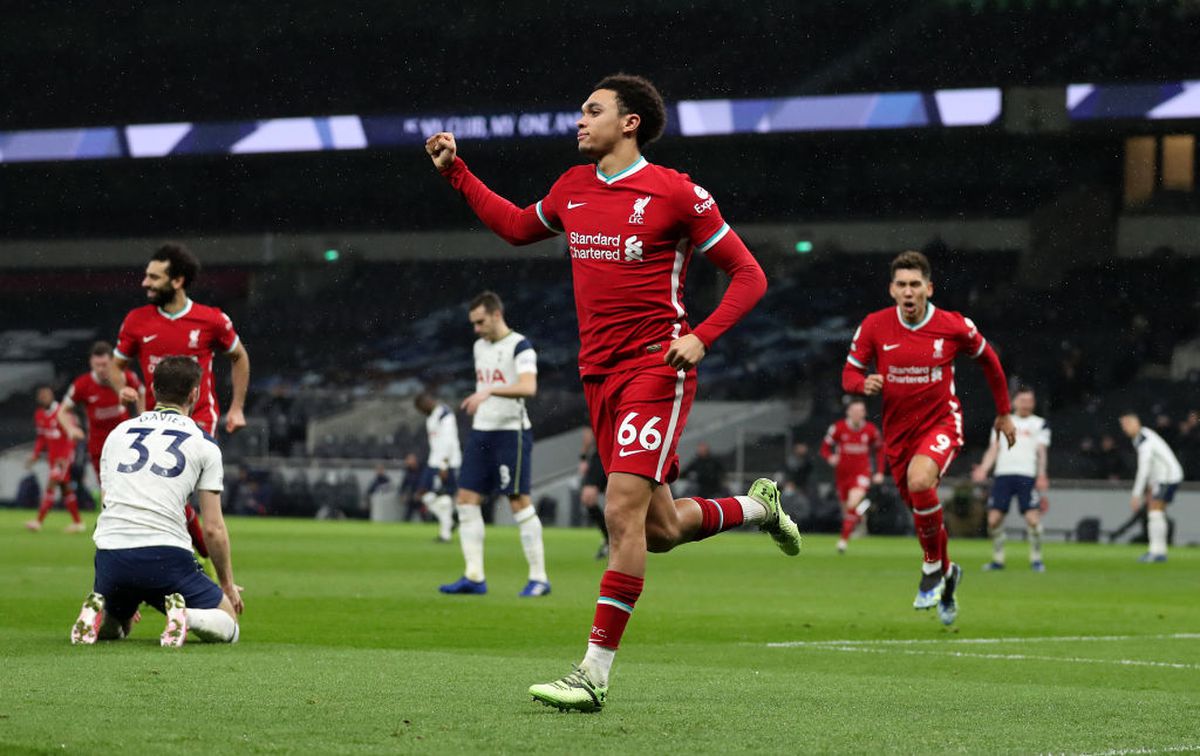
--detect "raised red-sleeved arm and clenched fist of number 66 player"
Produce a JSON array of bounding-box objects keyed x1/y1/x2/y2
[{"x1": 425, "y1": 131, "x2": 562, "y2": 245}]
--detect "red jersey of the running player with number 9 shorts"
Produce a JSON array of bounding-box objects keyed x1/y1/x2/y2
[{"x1": 846, "y1": 302, "x2": 1008, "y2": 446}]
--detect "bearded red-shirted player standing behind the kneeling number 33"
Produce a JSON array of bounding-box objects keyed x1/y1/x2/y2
[{"x1": 109, "y1": 244, "x2": 250, "y2": 558}]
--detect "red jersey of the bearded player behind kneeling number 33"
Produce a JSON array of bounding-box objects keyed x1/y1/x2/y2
[{"x1": 114, "y1": 300, "x2": 238, "y2": 433}]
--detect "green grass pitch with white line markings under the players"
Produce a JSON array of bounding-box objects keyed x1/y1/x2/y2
[{"x1": 0, "y1": 511, "x2": 1200, "y2": 754}]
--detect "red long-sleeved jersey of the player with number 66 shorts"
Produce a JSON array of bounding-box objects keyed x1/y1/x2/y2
[{"x1": 444, "y1": 156, "x2": 767, "y2": 376}]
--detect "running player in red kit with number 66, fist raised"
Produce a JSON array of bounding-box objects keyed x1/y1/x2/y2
[{"x1": 425, "y1": 74, "x2": 800, "y2": 712}]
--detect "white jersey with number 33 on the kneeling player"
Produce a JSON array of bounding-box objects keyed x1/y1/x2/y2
[{"x1": 92, "y1": 410, "x2": 224, "y2": 551}]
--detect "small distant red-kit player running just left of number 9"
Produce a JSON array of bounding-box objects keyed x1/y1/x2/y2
[{"x1": 821, "y1": 398, "x2": 883, "y2": 554}]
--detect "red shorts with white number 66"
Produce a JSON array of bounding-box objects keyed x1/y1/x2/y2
[{"x1": 583, "y1": 366, "x2": 696, "y2": 484}]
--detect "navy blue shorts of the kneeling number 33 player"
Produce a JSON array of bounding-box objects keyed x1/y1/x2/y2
[{"x1": 92, "y1": 546, "x2": 224, "y2": 622}]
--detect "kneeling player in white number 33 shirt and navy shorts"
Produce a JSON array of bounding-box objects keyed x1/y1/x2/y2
[{"x1": 71, "y1": 356, "x2": 242, "y2": 647}]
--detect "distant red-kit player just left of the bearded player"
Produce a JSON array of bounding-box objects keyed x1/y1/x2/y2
[{"x1": 58, "y1": 341, "x2": 145, "y2": 480}]
